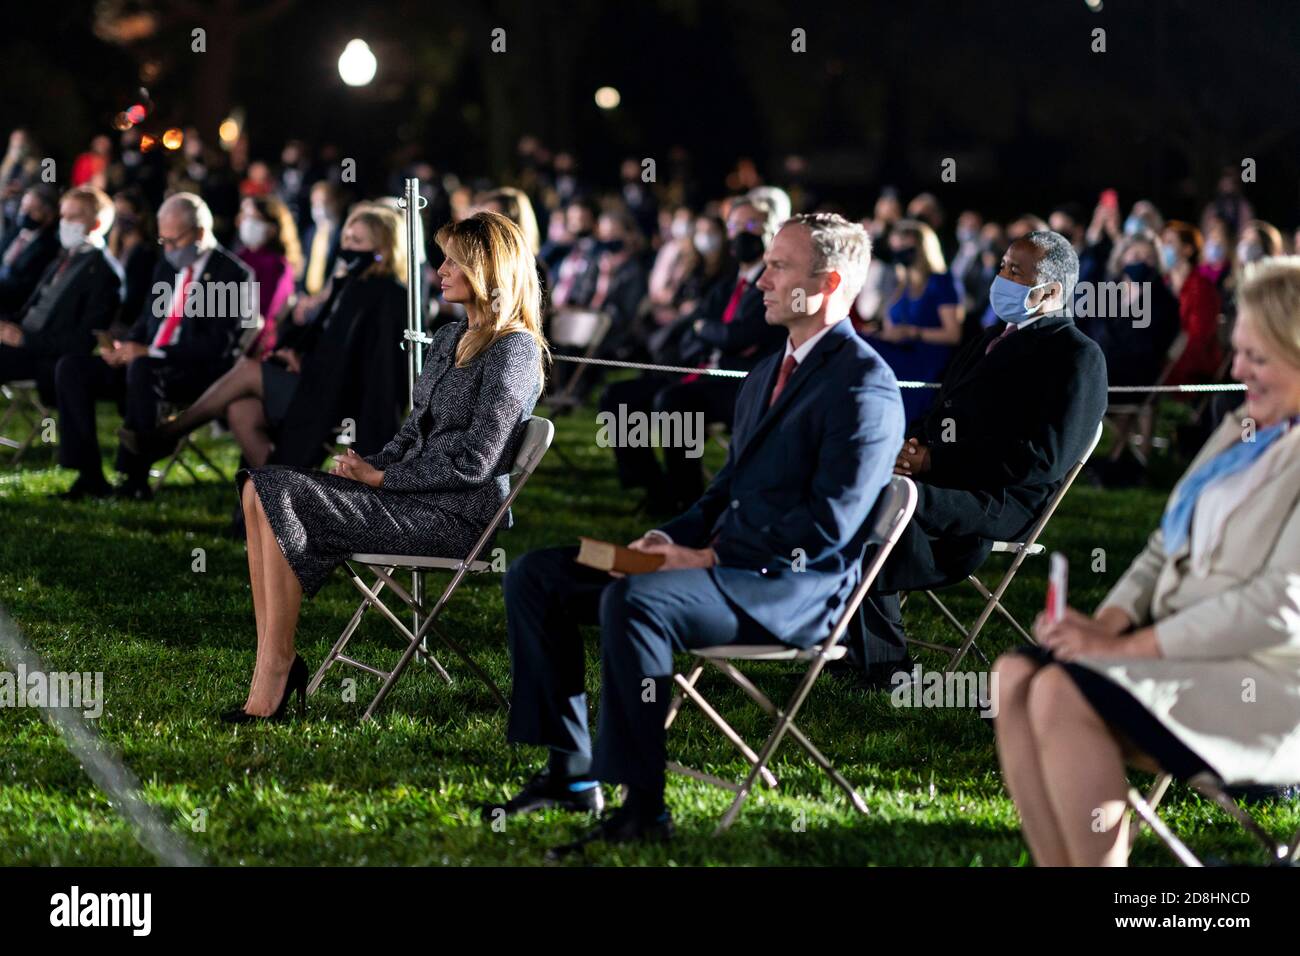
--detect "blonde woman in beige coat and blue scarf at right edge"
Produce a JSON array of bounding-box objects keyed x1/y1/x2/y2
[{"x1": 995, "y1": 256, "x2": 1300, "y2": 866}]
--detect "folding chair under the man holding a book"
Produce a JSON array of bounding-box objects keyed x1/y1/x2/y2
[{"x1": 664, "y1": 476, "x2": 917, "y2": 832}]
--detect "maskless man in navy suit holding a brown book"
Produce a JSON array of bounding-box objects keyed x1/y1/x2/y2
[{"x1": 482, "y1": 213, "x2": 904, "y2": 849}]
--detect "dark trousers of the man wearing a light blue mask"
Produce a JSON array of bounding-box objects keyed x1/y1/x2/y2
[{"x1": 845, "y1": 481, "x2": 1034, "y2": 667}]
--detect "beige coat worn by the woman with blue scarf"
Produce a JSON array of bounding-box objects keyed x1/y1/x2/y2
[{"x1": 1078, "y1": 407, "x2": 1300, "y2": 784}]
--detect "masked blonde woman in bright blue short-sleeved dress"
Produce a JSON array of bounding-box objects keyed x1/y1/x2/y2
[{"x1": 867, "y1": 219, "x2": 962, "y2": 421}]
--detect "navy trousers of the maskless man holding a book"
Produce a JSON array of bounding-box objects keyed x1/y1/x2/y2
[{"x1": 504, "y1": 548, "x2": 779, "y2": 792}]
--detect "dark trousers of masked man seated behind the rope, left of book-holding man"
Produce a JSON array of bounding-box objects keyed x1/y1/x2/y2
[{"x1": 601, "y1": 376, "x2": 742, "y2": 509}]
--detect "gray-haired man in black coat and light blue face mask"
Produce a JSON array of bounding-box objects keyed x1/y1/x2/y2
[{"x1": 849, "y1": 232, "x2": 1106, "y2": 687}]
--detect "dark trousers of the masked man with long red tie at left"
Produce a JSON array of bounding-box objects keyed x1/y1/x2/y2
[{"x1": 55, "y1": 355, "x2": 229, "y2": 483}]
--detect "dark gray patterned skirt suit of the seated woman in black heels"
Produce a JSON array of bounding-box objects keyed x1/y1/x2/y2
[{"x1": 235, "y1": 320, "x2": 541, "y2": 597}]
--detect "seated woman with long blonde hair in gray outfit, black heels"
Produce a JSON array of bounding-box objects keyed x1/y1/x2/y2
[{"x1": 222, "y1": 212, "x2": 547, "y2": 722}]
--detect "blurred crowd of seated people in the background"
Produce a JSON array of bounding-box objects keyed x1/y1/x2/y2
[{"x1": 0, "y1": 121, "x2": 1300, "y2": 499}]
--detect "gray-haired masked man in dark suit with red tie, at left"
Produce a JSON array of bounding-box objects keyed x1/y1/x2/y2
[{"x1": 55, "y1": 193, "x2": 259, "y2": 499}]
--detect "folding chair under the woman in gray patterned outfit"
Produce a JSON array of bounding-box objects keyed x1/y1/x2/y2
[{"x1": 314, "y1": 416, "x2": 555, "y2": 721}]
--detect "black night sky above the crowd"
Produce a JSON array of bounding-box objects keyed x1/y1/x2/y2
[{"x1": 0, "y1": 0, "x2": 1300, "y2": 228}]
